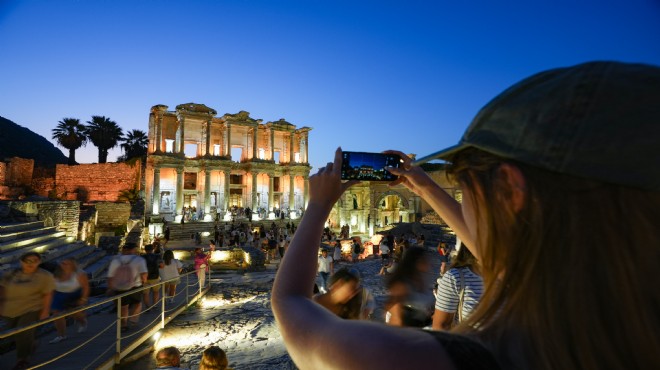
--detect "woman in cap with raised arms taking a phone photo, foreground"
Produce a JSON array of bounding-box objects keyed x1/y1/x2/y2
[{"x1": 272, "y1": 62, "x2": 660, "y2": 369}]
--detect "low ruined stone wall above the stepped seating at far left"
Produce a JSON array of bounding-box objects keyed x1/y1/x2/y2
[{"x1": 0, "y1": 200, "x2": 80, "y2": 239}]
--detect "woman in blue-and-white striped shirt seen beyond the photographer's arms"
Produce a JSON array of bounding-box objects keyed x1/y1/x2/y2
[{"x1": 433, "y1": 244, "x2": 484, "y2": 330}]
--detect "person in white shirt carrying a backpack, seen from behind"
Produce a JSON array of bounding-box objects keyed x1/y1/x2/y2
[{"x1": 108, "y1": 243, "x2": 147, "y2": 332}]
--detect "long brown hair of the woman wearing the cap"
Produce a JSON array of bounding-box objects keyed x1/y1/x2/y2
[{"x1": 448, "y1": 144, "x2": 660, "y2": 369}]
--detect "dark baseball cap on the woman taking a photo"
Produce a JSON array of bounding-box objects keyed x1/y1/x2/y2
[{"x1": 413, "y1": 61, "x2": 660, "y2": 190}]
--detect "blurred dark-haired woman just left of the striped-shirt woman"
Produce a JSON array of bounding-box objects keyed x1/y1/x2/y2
[{"x1": 385, "y1": 247, "x2": 435, "y2": 328}]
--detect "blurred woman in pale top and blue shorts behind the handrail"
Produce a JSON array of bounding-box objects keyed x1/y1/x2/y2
[{"x1": 48, "y1": 257, "x2": 89, "y2": 344}]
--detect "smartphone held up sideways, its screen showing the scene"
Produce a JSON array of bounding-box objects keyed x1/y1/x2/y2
[{"x1": 341, "y1": 152, "x2": 403, "y2": 181}]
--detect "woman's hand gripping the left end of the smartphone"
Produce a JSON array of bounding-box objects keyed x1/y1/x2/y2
[{"x1": 309, "y1": 148, "x2": 359, "y2": 210}]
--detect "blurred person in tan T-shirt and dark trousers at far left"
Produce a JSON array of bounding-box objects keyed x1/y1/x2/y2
[{"x1": 0, "y1": 252, "x2": 55, "y2": 369}]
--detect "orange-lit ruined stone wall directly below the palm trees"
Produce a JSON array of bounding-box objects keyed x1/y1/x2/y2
[{"x1": 55, "y1": 161, "x2": 140, "y2": 202}]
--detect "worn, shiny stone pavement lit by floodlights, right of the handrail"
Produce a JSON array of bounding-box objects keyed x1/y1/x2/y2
[{"x1": 121, "y1": 249, "x2": 440, "y2": 370}]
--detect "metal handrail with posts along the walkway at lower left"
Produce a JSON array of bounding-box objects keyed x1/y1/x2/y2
[{"x1": 0, "y1": 267, "x2": 211, "y2": 369}]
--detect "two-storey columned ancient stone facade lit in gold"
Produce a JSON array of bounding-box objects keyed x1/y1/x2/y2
[{"x1": 145, "y1": 103, "x2": 311, "y2": 221}]
